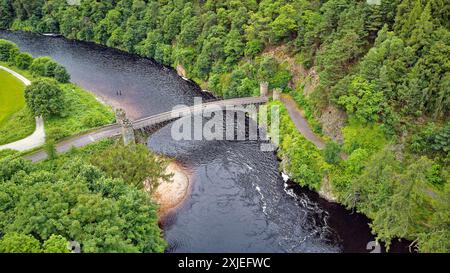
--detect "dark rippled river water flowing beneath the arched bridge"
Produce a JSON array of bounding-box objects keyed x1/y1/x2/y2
[{"x1": 0, "y1": 30, "x2": 405, "y2": 252}]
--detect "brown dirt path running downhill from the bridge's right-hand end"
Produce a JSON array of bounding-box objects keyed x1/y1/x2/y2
[{"x1": 280, "y1": 94, "x2": 325, "y2": 150}]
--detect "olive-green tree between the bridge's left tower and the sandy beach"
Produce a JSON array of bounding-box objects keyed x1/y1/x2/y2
[{"x1": 92, "y1": 144, "x2": 170, "y2": 191}]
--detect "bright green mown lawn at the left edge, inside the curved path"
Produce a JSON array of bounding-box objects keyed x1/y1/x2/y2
[{"x1": 0, "y1": 70, "x2": 36, "y2": 145}]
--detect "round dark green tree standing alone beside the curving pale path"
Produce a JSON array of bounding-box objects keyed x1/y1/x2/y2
[{"x1": 25, "y1": 79, "x2": 64, "y2": 117}]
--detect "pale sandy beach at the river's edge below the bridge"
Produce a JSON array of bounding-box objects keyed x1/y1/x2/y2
[{"x1": 153, "y1": 162, "x2": 191, "y2": 218}]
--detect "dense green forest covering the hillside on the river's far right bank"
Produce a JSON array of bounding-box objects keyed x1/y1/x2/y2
[{"x1": 0, "y1": 0, "x2": 450, "y2": 252}]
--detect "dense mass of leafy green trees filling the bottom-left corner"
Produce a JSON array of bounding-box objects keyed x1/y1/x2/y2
[{"x1": 0, "y1": 154, "x2": 166, "y2": 252}]
